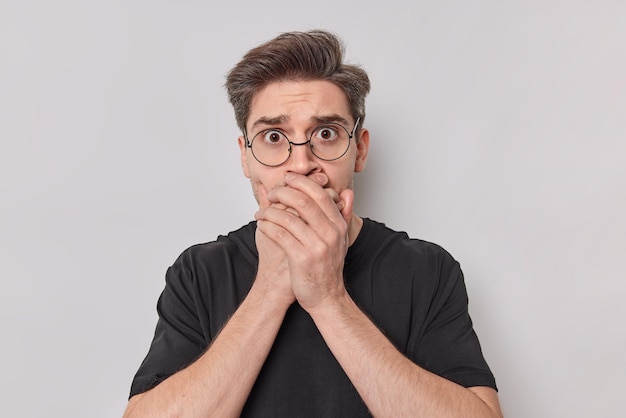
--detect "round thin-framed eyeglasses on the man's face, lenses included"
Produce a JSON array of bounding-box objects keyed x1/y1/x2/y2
[{"x1": 244, "y1": 118, "x2": 361, "y2": 167}]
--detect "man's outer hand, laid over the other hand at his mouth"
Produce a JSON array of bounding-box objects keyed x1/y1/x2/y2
[{"x1": 256, "y1": 173, "x2": 354, "y2": 310}]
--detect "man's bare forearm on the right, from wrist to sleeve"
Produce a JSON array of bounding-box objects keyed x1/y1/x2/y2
[{"x1": 310, "y1": 294, "x2": 501, "y2": 417}]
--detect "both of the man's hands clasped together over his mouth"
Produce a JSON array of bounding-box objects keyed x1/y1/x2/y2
[{"x1": 255, "y1": 172, "x2": 354, "y2": 312}]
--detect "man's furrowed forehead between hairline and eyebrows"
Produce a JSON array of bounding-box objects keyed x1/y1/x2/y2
[{"x1": 248, "y1": 80, "x2": 350, "y2": 126}]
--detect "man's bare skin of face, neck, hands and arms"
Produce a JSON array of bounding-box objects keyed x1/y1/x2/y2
[{"x1": 125, "y1": 80, "x2": 502, "y2": 417}]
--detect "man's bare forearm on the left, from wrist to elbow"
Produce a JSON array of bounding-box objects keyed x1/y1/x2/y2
[{"x1": 124, "y1": 286, "x2": 287, "y2": 418}]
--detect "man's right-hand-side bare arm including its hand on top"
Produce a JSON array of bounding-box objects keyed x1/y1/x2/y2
[{"x1": 257, "y1": 171, "x2": 501, "y2": 417}]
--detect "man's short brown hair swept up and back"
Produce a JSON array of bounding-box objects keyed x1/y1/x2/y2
[{"x1": 225, "y1": 30, "x2": 370, "y2": 132}]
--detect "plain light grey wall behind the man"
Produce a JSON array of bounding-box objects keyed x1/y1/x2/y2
[{"x1": 0, "y1": 0, "x2": 626, "y2": 418}]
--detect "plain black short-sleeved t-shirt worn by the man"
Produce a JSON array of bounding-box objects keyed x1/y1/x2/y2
[{"x1": 130, "y1": 219, "x2": 496, "y2": 417}]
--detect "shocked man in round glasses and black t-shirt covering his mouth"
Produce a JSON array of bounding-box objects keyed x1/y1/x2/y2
[{"x1": 125, "y1": 31, "x2": 501, "y2": 417}]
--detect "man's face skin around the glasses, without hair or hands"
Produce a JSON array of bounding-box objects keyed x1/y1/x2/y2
[{"x1": 239, "y1": 80, "x2": 369, "y2": 207}]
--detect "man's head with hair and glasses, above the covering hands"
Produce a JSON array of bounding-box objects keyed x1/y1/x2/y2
[{"x1": 226, "y1": 31, "x2": 369, "y2": 211}]
